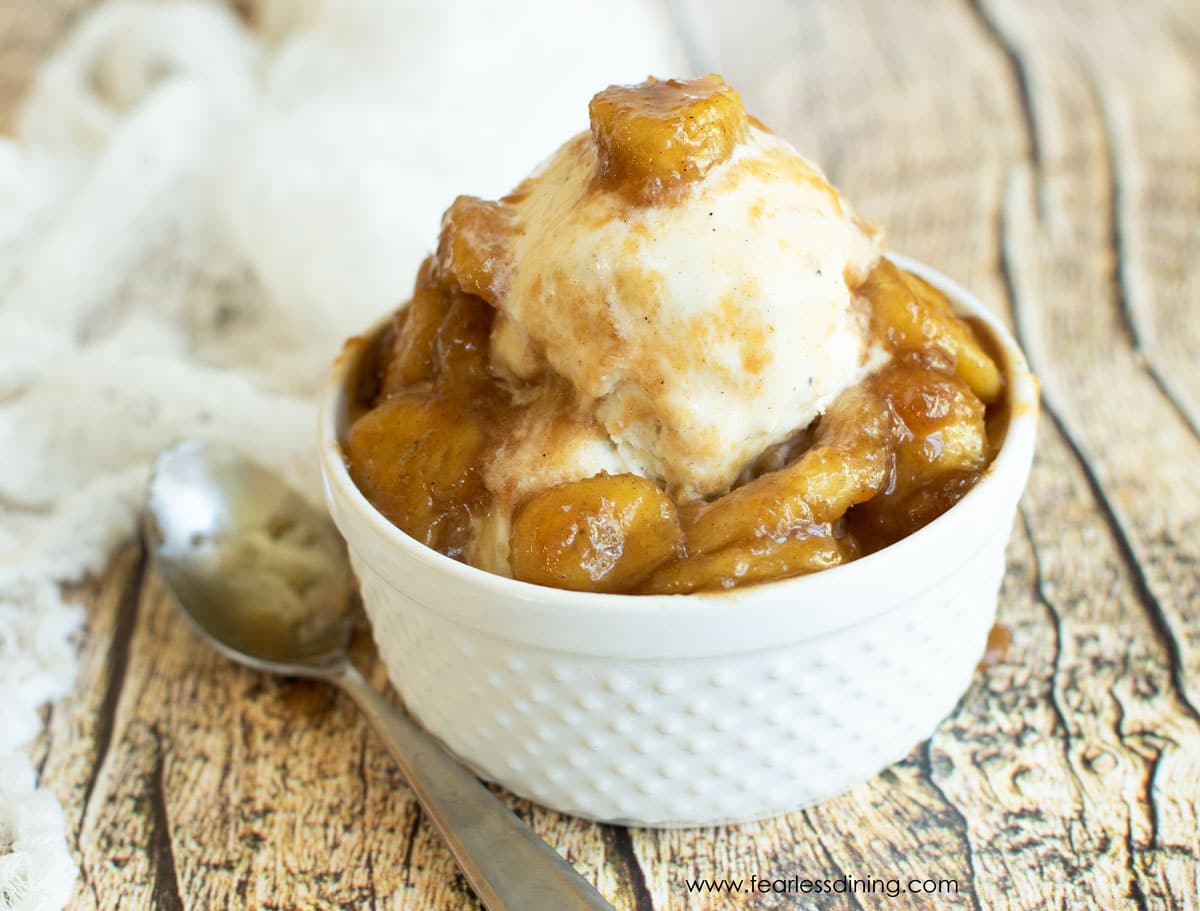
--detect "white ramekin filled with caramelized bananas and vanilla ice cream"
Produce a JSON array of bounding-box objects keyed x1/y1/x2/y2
[{"x1": 319, "y1": 76, "x2": 1038, "y2": 826}]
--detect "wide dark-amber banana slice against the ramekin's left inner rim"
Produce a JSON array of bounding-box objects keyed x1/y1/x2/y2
[{"x1": 346, "y1": 386, "x2": 486, "y2": 557}]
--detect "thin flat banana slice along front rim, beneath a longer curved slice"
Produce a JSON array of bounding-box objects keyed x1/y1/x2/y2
[{"x1": 640, "y1": 525, "x2": 854, "y2": 594}]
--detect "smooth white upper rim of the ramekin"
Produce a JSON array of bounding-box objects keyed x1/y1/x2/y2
[{"x1": 318, "y1": 251, "x2": 1039, "y2": 627}]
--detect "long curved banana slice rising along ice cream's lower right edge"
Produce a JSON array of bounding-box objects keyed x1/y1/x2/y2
[{"x1": 688, "y1": 386, "x2": 892, "y2": 555}]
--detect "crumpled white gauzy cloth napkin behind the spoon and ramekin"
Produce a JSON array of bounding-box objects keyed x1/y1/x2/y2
[{"x1": 0, "y1": 0, "x2": 685, "y2": 911}]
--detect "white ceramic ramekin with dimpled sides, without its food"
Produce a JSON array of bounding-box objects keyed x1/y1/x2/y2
[{"x1": 320, "y1": 256, "x2": 1038, "y2": 826}]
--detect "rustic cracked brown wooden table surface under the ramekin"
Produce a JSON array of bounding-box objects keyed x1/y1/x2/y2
[{"x1": 16, "y1": 0, "x2": 1200, "y2": 911}]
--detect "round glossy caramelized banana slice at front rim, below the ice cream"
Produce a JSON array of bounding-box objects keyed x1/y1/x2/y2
[{"x1": 509, "y1": 474, "x2": 683, "y2": 592}]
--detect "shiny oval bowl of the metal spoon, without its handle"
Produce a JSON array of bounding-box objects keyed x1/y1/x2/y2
[{"x1": 146, "y1": 439, "x2": 354, "y2": 676}]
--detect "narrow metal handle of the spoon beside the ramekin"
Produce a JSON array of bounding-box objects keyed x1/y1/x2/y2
[{"x1": 331, "y1": 661, "x2": 613, "y2": 911}]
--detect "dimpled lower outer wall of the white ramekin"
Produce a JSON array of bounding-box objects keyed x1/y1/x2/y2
[{"x1": 355, "y1": 549, "x2": 1003, "y2": 827}]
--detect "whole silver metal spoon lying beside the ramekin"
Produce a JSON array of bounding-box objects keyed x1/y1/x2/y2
[{"x1": 146, "y1": 439, "x2": 612, "y2": 911}]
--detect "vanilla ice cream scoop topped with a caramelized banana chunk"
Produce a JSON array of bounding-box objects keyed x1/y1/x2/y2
[{"x1": 434, "y1": 77, "x2": 883, "y2": 497}]
